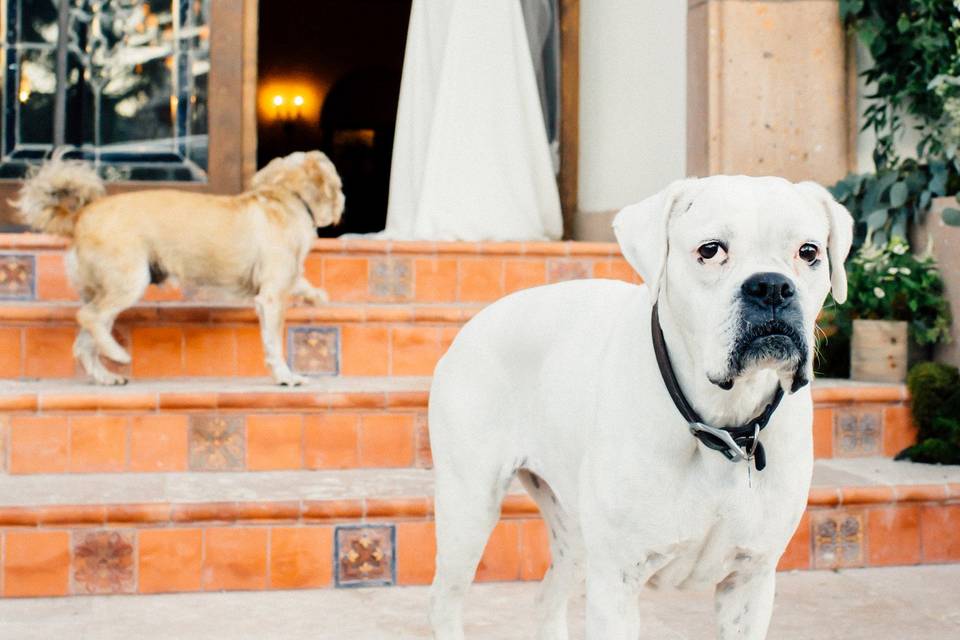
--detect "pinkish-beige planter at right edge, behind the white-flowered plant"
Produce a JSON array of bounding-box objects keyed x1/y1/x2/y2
[{"x1": 910, "y1": 196, "x2": 960, "y2": 367}]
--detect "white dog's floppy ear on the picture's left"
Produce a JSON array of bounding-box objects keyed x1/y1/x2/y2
[{"x1": 613, "y1": 178, "x2": 696, "y2": 301}]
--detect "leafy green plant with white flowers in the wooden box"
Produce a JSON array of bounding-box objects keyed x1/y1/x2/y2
[{"x1": 835, "y1": 237, "x2": 950, "y2": 345}]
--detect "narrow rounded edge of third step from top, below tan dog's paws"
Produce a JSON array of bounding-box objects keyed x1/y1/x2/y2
[{"x1": 0, "y1": 382, "x2": 909, "y2": 412}]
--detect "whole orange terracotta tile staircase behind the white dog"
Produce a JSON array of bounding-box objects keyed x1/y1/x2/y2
[{"x1": 0, "y1": 235, "x2": 960, "y2": 596}]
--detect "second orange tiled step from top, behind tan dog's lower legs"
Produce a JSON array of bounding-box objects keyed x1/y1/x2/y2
[{"x1": 0, "y1": 304, "x2": 480, "y2": 380}]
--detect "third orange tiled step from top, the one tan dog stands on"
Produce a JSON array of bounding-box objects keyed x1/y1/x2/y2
[{"x1": 0, "y1": 377, "x2": 914, "y2": 474}]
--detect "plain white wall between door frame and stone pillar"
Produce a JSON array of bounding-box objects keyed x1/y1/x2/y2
[{"x1": 579, "y1": 0, "x2": 687, "y2": 215}]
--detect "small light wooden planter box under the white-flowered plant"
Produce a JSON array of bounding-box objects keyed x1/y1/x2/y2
[{"x1": 850, "y1": 320, "x2": 908, "y2": 382}]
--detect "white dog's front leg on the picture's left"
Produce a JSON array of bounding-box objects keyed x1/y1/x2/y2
[{"x1": 587, "y1": 559, "x2": 640, "y2": 640}]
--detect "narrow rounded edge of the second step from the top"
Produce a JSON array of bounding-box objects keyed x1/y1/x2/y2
[{"x1": 0, "y1": 302, "x2": 484, "y2": 325}]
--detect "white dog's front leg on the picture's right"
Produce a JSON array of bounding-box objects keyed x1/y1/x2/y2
[{"x1": 714, "y1": 568, "x2": 776, "y2": 640}]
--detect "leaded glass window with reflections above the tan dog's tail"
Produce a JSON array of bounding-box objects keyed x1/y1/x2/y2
[{"x1": 0, "y1": 0, "x2": 210, "y2": 182}]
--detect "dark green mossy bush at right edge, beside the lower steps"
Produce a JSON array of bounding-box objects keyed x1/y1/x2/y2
[{"x1": 897, "y1": 362, "x2": 960, "y2": 464}]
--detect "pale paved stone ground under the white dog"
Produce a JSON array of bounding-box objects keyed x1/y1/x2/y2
[{"x1": 0, "y1": 565, "x2": 960, "y2": 640}]
